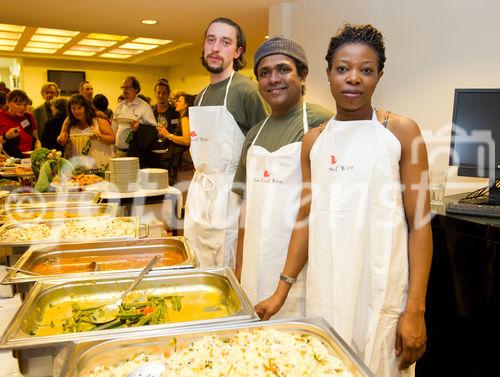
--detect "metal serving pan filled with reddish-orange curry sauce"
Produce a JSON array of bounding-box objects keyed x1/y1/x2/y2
[{"x1": 2, "y1": 237, "x2": 199, "y2": 292}]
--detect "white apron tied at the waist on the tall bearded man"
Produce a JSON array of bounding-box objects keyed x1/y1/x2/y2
[{"x1": 184, "y1": 72, "x2": 245, "y2": 269}]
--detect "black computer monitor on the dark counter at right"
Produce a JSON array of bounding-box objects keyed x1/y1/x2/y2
[{"x1": 450, "y1": 89, "x2": 500, "y2": 204}]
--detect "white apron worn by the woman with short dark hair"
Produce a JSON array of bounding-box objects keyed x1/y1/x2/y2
[{"x1": 306, "y1": 111, "x2": 414, "y2": 377}]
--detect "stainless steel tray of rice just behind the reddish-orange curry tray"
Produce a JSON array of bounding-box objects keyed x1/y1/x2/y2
[{"x1": 0, "y1": 217, "x2": 145, "y2": 252}]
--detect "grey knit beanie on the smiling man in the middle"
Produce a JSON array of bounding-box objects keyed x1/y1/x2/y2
[{"x1": 253, "y1": 36, "x2": 309, "y2": 76}]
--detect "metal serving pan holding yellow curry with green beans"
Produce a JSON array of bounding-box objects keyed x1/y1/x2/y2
[{"x1": 0, "y1": 268, "x2": 257, "y2": 357}]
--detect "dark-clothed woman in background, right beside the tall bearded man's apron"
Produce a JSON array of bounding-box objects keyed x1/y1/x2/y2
[{"x1": 156, "y1": 92, "x2": 195, "y2": 185}]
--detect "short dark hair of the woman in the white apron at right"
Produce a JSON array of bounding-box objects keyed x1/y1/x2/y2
[{"x1": 325, "y1": 24, "x2": 385, "y2": 72}]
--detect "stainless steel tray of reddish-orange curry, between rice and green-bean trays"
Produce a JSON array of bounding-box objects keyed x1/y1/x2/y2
[{"x1": 2, "y1": 237, "x2": 199, "y2": 291}]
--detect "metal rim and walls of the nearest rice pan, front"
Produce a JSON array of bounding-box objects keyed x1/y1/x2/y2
[{"x1": 59, "y1": 318, "x2": 375, "y2": 377}]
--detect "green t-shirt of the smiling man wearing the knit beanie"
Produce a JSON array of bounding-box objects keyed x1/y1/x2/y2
[{"x1": 232, "y1": 103, "x2": 333, "y2": 196}]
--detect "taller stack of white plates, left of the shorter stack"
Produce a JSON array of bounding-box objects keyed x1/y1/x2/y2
[{"x1": 109, "y1": 157, "x2": 139, "y2": 192}]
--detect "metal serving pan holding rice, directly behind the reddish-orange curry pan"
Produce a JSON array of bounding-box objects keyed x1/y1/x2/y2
[{"x1": 0, "y1": 217, "x2": 148, "y2": 255}]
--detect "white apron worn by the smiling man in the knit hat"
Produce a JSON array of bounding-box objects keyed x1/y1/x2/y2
[{"x1": 241, "y1": 103, "x2": 309, "y2": 318}]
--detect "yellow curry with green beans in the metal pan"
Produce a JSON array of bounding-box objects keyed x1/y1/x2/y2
[{"x1": 30, "y1": 289, "x2": 232, "y2": 336}]
